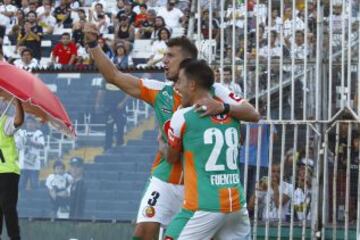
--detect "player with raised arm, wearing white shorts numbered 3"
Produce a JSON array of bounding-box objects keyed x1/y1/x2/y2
[{"x1": 84, "y1": 24, "x2": 259, "y2": 240}]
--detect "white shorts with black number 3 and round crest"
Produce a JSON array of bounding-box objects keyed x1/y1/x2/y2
[{"x1": 136, "y1": 176, "x2": 184, "y2": 227}]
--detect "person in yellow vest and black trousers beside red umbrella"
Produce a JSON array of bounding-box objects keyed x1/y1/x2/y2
[{"x1": 0, "y1": 100, "x2": 24, "y2": 240}]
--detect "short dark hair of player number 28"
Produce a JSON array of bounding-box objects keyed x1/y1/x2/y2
[{"x1": 180, "y1": 59, "x2": 214, "y2": 90}]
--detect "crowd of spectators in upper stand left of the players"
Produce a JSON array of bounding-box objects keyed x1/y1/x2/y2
[{"x1": 0, "y1": 0, "x2": 189, "y2": 70}]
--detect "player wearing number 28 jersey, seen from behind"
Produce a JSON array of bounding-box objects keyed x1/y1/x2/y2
[{"x1": 165, "y1": 60, "x2": 251, "y2": 240}]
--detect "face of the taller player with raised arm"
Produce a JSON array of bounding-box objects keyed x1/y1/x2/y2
[{"x1": 163, "y1": 46, "x2": 184, "y2": 82}]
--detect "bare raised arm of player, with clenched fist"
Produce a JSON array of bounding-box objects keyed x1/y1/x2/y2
[{"x1": 84, "y1": 23, "x2": 141, "y2": 98}]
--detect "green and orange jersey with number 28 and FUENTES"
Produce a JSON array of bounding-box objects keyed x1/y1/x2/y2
[{"x1": 168, "y1": 107, "x2": 246, "y2": 213}]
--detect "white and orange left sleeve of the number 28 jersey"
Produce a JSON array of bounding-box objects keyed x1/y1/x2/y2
[{"x1": 168, "y1": 109, "x2": 185, "y2": 151}]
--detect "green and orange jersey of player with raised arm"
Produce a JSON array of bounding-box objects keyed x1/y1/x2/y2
[{"x1": 140, "y1": 79, "x2": 243, "y2": 184}]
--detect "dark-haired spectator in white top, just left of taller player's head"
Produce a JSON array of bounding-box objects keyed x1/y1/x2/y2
[{"x1": 147, "y1": 28, "x2": 171, "y2": 66}]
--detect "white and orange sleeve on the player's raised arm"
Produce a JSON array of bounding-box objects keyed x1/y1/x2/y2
[{"x1": 140, "y1": 79, "x2": 166, "y2": 105}]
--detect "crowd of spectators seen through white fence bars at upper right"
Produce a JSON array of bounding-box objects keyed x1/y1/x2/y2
[{"x1": 198, "y1": 0, "x2": 359, "y2": 99}]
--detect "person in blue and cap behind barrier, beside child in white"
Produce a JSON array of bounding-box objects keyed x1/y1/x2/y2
[{"x1": 69, "y1": 157, "x2": 87, "y2": 219}]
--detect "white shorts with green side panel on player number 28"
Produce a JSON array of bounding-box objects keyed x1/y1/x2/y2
[{"x1": 165, "y1": 208, "x2": 251, "y2": 240}]
